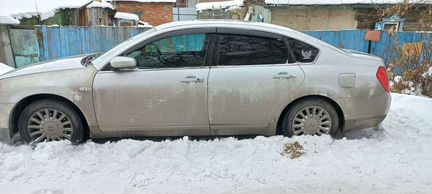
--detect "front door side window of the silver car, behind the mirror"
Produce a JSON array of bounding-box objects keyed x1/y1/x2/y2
[{"x1": 127, "y1": 34, "x2": 208, "y2": 69}]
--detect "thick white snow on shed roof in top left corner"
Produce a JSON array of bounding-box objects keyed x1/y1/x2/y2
[{"x1": 0, "y1": 0, "x2": 92, "y2": 23}]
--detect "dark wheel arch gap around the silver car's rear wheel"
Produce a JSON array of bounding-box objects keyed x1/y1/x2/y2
[{"x1": 276, "y1": 95, "x2": 345, "y2": 135}]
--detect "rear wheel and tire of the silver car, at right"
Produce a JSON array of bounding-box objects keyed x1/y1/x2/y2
[{"x1": 282, "y1": 98, "x2": 339, "y2": 137}]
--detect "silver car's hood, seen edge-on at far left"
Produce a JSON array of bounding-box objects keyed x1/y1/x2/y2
[{"x1": 0, "y1": 56, "x2": 84, "y2": 79}]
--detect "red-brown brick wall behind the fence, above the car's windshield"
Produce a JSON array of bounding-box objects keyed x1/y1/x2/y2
[{"x1": 116, "y1": 1, "x2": 173, "y2": 26}]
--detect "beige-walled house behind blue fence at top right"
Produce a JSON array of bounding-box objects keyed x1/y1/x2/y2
[{"x1": 264, "y1": 0, "x2": 432, "y2": 31}]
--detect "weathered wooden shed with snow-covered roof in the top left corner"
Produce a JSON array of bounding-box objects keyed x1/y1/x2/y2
[{"x1": 0, "y1": 0, "x2": 114, "y2": 26}]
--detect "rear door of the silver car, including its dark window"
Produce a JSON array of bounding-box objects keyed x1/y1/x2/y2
[{"x1": 208, "y1": 29, "x2": 304, "y2": 134}]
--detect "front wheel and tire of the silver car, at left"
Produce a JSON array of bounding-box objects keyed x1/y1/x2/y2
[{"x1": 18, "y1": 99, "x2": 84, "y2": 144}]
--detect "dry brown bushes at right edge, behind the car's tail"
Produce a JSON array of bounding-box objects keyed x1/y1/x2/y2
[{"x1": 377, "y1": 0, "x2": 432, "y2": 97}]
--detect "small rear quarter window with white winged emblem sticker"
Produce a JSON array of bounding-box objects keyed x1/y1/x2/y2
[{"x1": 287, "y1": 38, "x2": 319, "y2": 63}]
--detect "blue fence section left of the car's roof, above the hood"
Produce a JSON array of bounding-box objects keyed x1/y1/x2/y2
[{"x1": 36, "y1": 26, "x2": 150, "y2": 60}]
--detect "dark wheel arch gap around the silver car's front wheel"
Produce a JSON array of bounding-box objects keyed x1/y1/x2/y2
[{"x1": 9, "y1": 94, "x2": 90, "y2": 138}]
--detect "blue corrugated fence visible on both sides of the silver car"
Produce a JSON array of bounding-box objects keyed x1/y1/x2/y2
[{"x1": 36, "y1": 26, "x2": 432, "y2": 65}]
